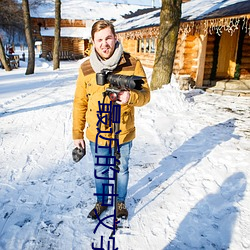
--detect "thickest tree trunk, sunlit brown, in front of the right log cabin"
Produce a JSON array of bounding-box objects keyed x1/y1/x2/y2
[{"x1": 150, "y1": 0, "x2": 182, "y2": 90}]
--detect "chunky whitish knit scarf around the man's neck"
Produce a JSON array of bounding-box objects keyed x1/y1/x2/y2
[{"x1": 90, "y1": 41, "x2": 123, "y2": 73}]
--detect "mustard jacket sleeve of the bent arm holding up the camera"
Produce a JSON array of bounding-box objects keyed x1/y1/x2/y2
[{"x1": 128, "y1": 60, "x2": 150, "y2": 107}]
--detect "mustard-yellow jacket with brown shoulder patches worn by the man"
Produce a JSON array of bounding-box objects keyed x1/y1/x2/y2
[{"x1": 73, "y1": 53, "x2": 150, "y2": 146}]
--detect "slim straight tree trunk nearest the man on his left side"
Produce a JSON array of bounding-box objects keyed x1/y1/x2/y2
[{"x1": 53, "y1": 0, "x2": 61, "y2": 70}]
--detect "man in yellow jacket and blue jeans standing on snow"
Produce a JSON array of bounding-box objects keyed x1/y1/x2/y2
[{"x1": 73, "y1": 20, "x2": 150, "y2": 219}]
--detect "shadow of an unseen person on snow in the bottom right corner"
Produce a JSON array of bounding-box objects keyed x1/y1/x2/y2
[{"x1": 163, "y1": 172, "x2": 247, "y2": 250}]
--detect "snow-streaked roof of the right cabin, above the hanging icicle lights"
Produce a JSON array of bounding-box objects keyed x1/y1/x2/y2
[{"x1": 114, "y1": 0, "x2": 250, "y2": 32}]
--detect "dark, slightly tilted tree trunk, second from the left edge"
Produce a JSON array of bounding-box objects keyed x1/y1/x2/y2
[{"x1": 22, "y1": 0, "x2": 35, "y2": 75}]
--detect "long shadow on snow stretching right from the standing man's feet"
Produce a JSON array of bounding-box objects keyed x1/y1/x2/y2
[{"x1": 128, "y1": 119, "x2": 239, "y2": 213}]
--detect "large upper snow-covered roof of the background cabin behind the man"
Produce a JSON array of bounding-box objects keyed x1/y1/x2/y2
[{"x1": 30, "y1": 0, "x2": 150, "y2": 20}]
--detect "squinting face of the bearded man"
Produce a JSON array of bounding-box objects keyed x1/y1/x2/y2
[{"x1": 93, "y1": 27, "x2": 117, "y2": 59}]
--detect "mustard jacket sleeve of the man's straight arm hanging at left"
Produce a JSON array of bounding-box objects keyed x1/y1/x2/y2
[{"x1": 72, "y1": 68, "x2": 88, "y2": 140}]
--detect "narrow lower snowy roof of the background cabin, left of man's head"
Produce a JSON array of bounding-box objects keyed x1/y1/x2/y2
[{"x1": 40, "y1": 27, "x2": 91, "y2": 39}]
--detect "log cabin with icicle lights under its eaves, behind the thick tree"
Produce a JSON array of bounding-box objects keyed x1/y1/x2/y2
[{"x1": 115, "y1": 0, "x2": 250, "y2": 90}]
